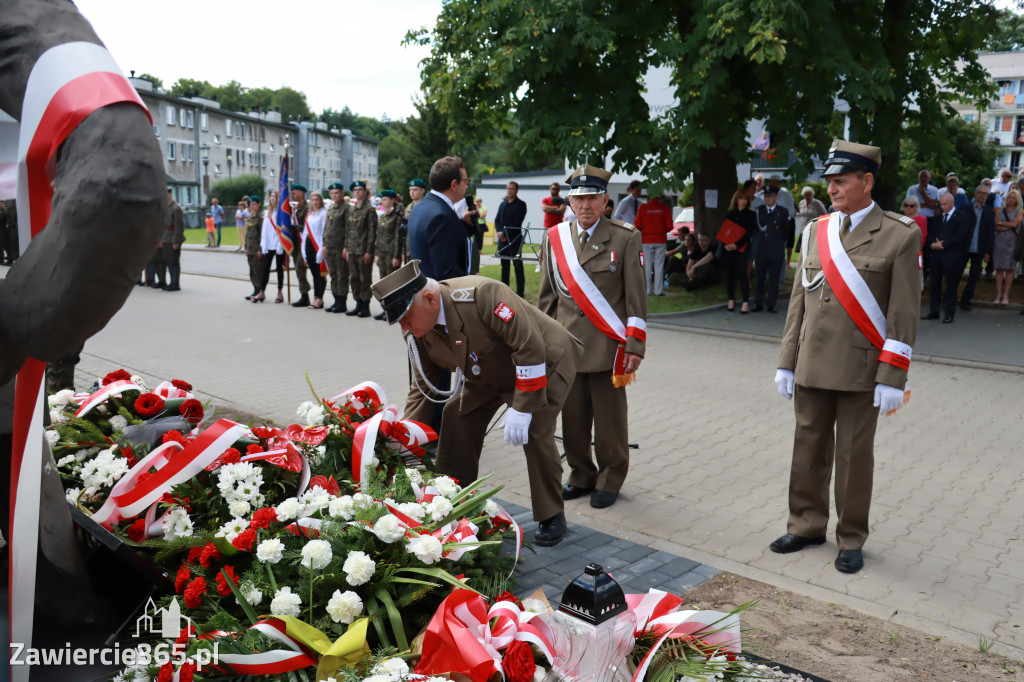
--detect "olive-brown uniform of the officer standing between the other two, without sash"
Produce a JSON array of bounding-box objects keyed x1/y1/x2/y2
[{"x1": 539, "y1": 217, "x2": 647, "y2": 493}]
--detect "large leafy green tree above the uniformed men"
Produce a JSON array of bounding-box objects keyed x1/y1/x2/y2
[{"x1": 407, "y1": 0, "x2": 993, "y2": 233}]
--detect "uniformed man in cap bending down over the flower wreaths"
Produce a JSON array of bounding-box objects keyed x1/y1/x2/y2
[{"x1": 373, "y1": 260, "x2": 583, "y2": 547}]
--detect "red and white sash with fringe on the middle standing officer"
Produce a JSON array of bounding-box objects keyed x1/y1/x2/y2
[{"x1": 548, "y1": 222, "x2": 647, "y2": 386}]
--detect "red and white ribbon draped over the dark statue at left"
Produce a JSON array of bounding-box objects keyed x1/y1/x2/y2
[{"x1": 6, "y1": 42, "x2": 152, "y2": 680}]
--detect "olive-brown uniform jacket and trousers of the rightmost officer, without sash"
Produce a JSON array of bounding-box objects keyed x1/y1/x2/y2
[{"x1": 778, "y1": 205, "x2": 921, "y2": 550}]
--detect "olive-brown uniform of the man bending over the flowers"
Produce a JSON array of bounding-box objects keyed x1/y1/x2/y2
[{"x1": 406, "y1": 276, "x2": 585, "y2": 520}]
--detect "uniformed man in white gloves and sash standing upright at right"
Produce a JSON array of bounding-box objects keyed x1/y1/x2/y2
[{"x1": 771, "y1": 140, "x2": 921, "y2": 573}]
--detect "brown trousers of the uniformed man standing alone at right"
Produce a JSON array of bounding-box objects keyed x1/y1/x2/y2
[{"x1": 786, "y1": 384, "x2": 879, "y2": 550}]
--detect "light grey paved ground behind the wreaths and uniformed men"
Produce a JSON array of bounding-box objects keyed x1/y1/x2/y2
[{"x1": 72, "y1": 270, "x2": 1024, "y2": 659}]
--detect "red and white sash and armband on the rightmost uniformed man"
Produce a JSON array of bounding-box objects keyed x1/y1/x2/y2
[{"x1": 817, "y1": 213, "x2": 912, "y2": 371}]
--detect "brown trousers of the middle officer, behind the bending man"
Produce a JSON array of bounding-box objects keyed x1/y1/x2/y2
[{"x1": 562, "y1": 370, "x2": 630, "y2": 493}]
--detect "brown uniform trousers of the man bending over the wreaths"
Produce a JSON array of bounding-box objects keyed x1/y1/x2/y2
[{"x1": 434, "y1": 366, "x2": 577, "y2": 521}]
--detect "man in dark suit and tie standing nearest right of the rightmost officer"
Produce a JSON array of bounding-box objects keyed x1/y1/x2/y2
[{"x1": 921, "y1": 193, "x2": 971, "y2": 325}]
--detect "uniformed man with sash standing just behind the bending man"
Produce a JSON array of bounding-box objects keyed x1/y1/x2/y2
[{"x1": 540, "y1": 166, "x2": 647, "y2": 509}]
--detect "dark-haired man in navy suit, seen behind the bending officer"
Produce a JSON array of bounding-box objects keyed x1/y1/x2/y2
[{"x1": 409, "y1": 157, "x2": 471, "y2": 280}]
